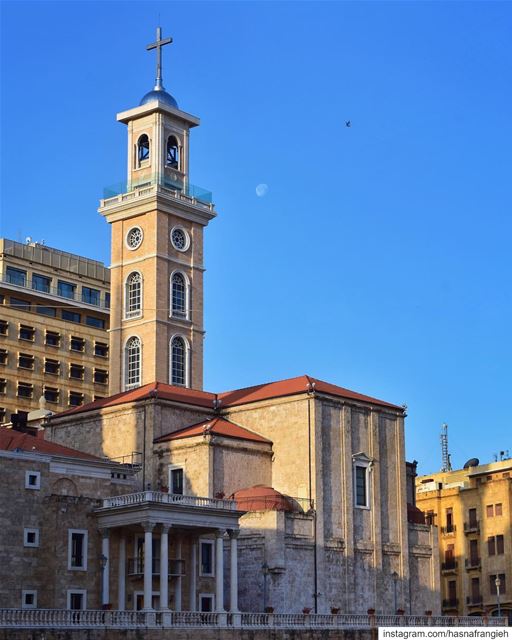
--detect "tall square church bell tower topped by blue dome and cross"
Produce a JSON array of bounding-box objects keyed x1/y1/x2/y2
[{"x1": 98, "y1": 27, "x2": 216, "y2": 394}]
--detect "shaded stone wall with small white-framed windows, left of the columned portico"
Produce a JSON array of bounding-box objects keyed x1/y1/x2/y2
[{"x1": 0, "y1": 454, "x2": 133, "y2": 609}]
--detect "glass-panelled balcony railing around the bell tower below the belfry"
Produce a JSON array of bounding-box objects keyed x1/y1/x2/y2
[{"x1": 101, "y1": 176, "x2": 213, "y2": 209}]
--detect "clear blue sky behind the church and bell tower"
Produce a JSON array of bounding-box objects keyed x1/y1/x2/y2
[{"x1": 1, "y1": 1, "x2": 512, "y2": 472}]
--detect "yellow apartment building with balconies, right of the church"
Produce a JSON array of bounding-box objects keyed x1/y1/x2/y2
[{"x1": 416, "y1": 458, "x2": 512, "y2": 618}]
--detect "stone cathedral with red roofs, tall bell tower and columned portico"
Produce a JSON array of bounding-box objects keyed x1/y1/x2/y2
[{"x1": 0, "y1": 30, "x2": 439, "y2": 614}]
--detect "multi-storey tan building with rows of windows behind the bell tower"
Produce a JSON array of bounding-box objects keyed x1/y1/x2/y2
[{"x1": 0, "y1": 239, "x2": 110, "y2": 422}]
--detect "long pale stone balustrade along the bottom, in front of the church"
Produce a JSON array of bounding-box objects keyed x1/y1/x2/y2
[{"x1": 0, "y1": 609, "x2": 507, "y2": 629}]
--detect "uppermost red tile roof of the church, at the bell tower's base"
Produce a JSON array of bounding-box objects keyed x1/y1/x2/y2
[{"x1": 50, "y1": 375, "x2": 403, "y2": 418}]
